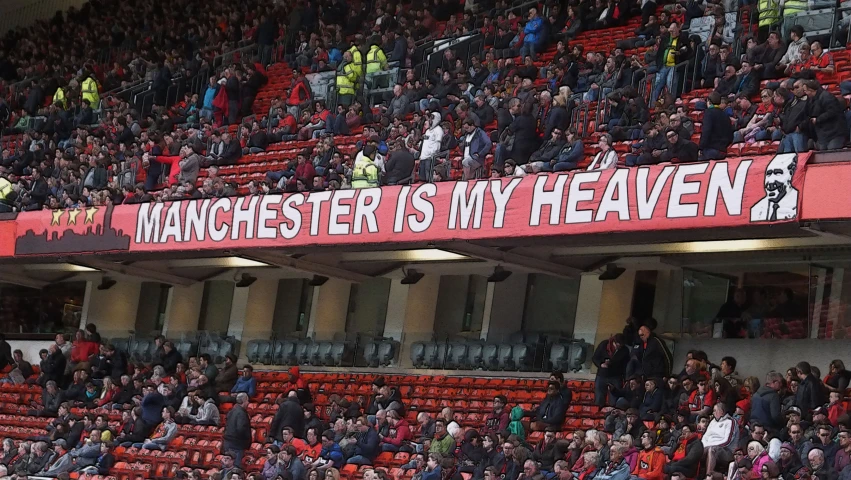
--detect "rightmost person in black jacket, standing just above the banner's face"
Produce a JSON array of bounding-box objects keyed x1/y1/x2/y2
[{"x1": 803, "y1": 80, "x2": 848, "y2": 150}]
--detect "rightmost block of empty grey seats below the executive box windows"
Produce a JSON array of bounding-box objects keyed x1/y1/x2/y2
[{"x1": 411, "y1": 340, "x2": 589, "y2": 372}]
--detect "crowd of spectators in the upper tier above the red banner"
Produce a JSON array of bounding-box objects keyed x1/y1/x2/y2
[{"x1": 0, "y1": 0, "x2": 851, "y2": 211}]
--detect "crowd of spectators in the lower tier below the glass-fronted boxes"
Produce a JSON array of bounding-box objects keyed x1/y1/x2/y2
[{"x1": 0, "y1": 319, "x2": 851, "y2": 480}]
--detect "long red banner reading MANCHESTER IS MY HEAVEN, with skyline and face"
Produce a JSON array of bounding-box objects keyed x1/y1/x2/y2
[{"x1": 8, "y1": 154, "x2": 809, "y2": 256}]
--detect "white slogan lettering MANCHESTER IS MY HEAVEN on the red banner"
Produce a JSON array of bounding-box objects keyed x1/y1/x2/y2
[{"x1": 126, "y1": 159, "x2": 792, "y2": 244}]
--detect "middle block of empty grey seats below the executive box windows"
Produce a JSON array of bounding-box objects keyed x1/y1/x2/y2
[{"x1": 246, "y1": 339, "x2": 398, "y2": 367}]
